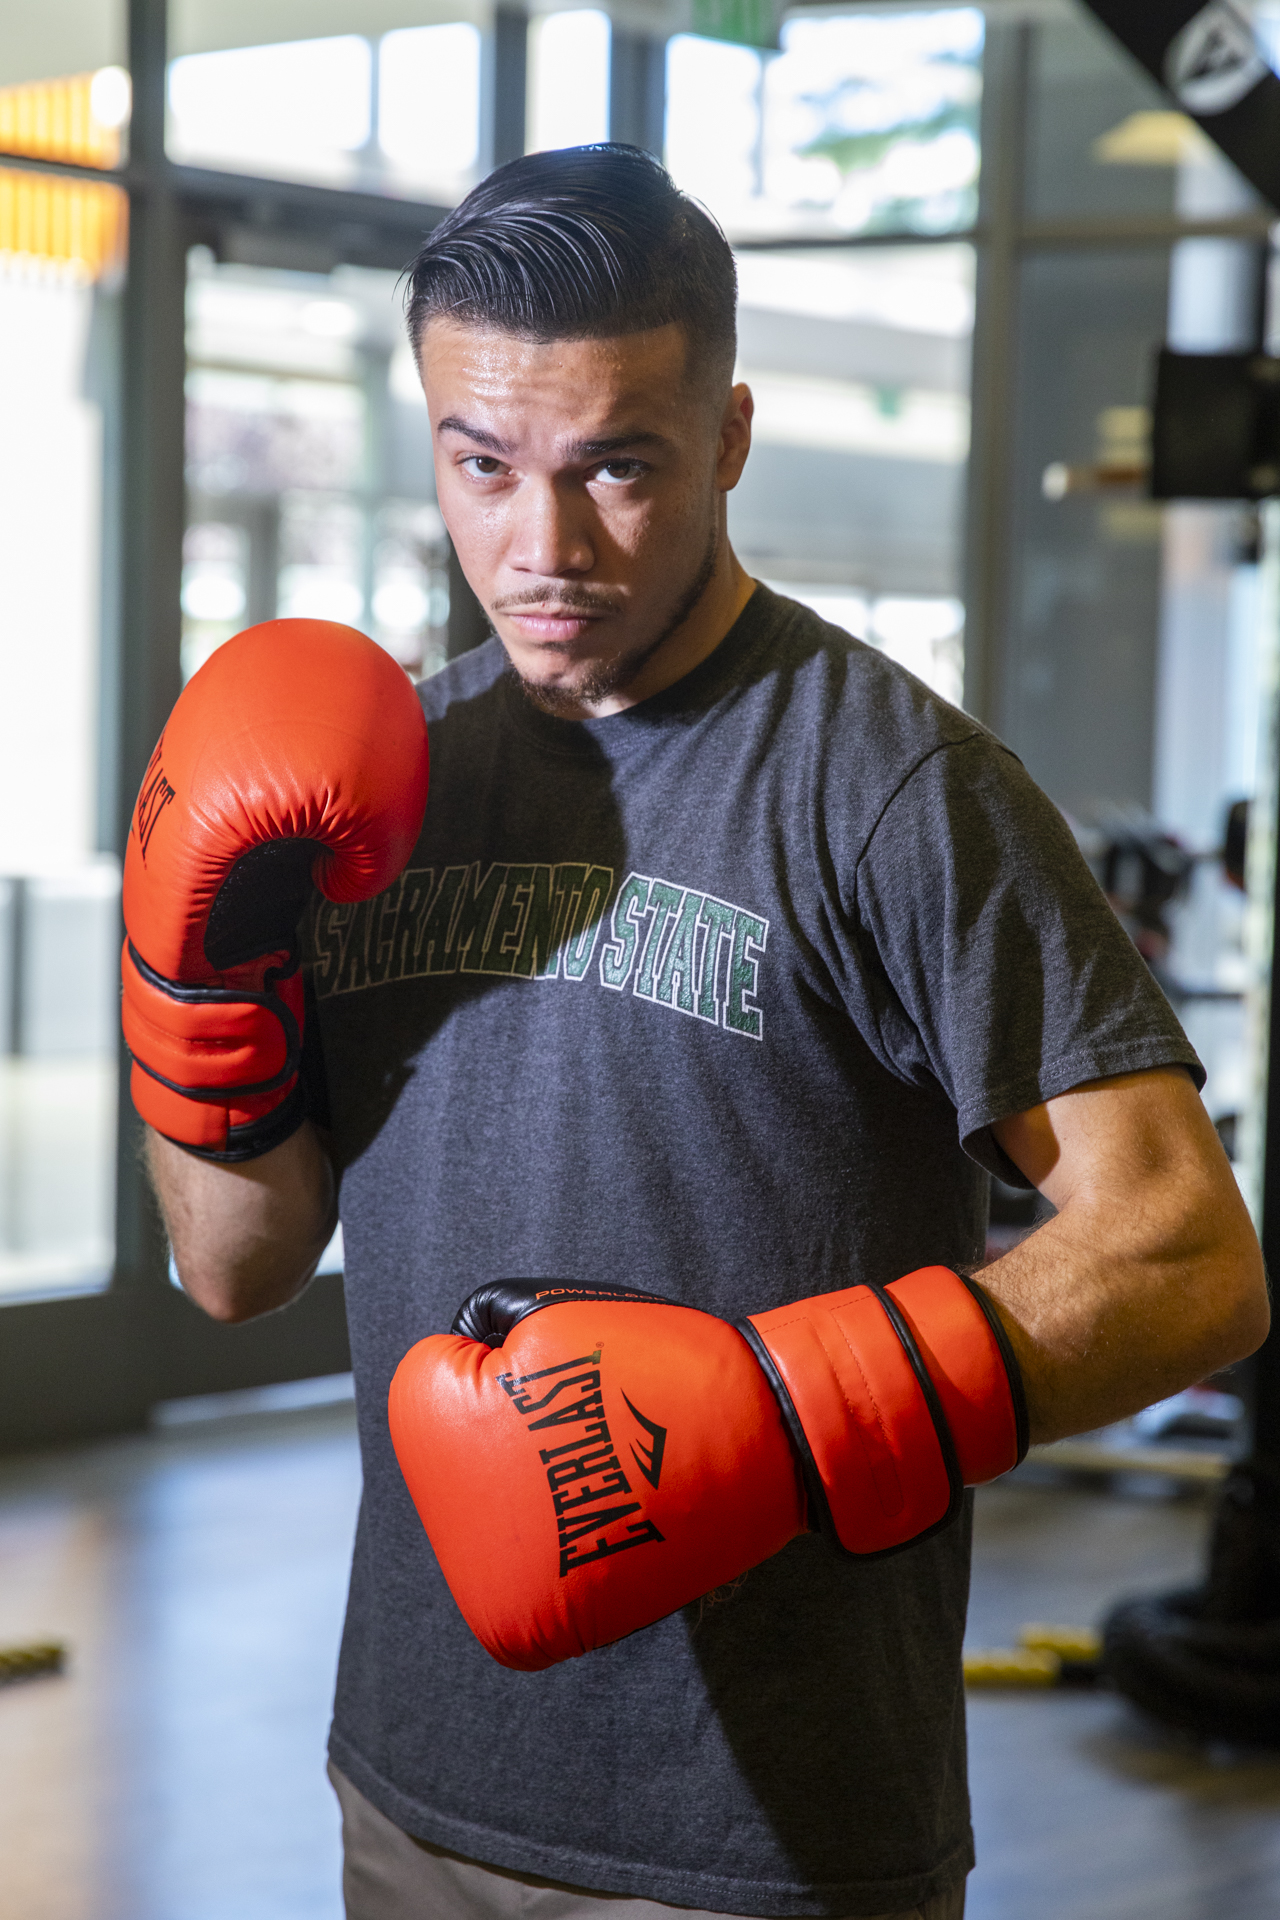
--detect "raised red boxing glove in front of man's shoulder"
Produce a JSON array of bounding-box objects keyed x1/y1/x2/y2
[{"x1": 123, "y1": 620, "x2": 428, "y2": 1160}]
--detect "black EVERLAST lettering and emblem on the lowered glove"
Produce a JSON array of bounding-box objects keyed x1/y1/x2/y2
[{"x1": 499, "y1": 1348, "x2": 666, "y2": 1574}]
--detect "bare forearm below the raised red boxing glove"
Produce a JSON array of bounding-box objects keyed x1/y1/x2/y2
[{"x1": 146, "y1": 1121, "x2": 338, "y2": 1321}]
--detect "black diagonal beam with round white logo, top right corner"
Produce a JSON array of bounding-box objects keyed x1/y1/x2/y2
[{"x1": 1086, "y1": 0, "x2": 1280, "y2": 209}]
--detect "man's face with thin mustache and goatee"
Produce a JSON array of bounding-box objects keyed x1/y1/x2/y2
[{"x1": 422, "y1": 319, "x2": 750, "y2": 712}]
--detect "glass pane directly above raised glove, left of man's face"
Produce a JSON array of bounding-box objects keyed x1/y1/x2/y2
[{"x1": 182, "y1": 252, "x2": 449, "y2": 678}]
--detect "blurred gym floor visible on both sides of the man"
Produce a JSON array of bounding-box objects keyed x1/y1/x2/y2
[{"x1": 0, "y1": 1407, "x2": 1280, "y2": 1920}]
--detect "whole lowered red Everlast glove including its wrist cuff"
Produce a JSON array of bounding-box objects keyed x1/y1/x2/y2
[{"x1": 388, "y1": 1267, "x2": 1027, "y2": 1672}]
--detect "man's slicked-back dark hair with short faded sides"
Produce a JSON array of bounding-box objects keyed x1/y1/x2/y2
[{"x1": 407, "y1": 140, "x2": 737, "y2": 397}]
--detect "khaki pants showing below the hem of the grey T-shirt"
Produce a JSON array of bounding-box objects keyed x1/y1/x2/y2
[{"x1": 328, "y1": 1766, "x2": 965, "y2": 1920}]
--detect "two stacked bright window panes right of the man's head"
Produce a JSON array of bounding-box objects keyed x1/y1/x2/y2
[{"x1": 666, "y1": 8, "x2": 983, "y2": 701}]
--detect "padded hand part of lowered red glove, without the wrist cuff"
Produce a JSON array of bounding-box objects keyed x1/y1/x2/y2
[{"x1": 390, "y1": 1281, "x2": 804, "y2": 1672}]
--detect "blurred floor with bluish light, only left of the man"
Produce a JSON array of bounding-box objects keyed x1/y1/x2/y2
[{"x1": 0, "y1": 1405, "x2": 359, "y2": 1920}]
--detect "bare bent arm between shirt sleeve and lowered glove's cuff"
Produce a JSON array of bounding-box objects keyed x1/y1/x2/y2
[{"x1": 979, "y1": 1071, "x2": 1267, "y2": 1440}]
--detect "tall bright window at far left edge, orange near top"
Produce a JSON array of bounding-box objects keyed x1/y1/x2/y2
[{"x1": 0, "y1": 8, "x2": 129, "y2": 1300}]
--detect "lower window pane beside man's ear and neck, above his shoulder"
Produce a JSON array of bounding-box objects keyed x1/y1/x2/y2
[{"x1": 729, "y1": 246, "x2": 973, "y2": 701}]
